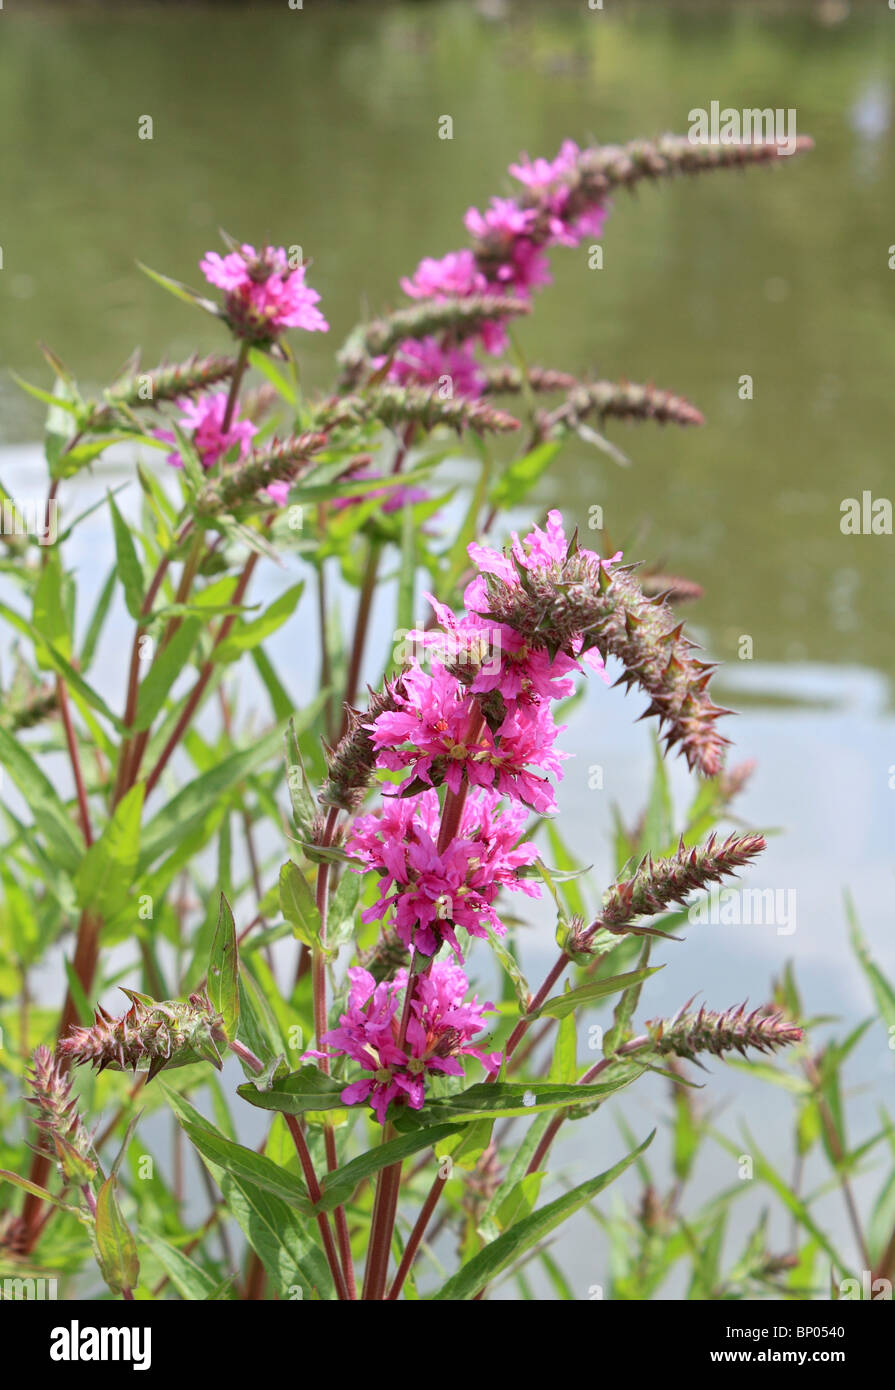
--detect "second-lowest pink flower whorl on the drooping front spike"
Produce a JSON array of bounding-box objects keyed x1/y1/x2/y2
[{"x1": 346, "y1": 790, "x2": 541, "y2": 959}]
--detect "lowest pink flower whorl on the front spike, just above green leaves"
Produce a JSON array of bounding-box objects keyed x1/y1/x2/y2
[{"x1": 312, "y1": 962, "x2": 500, "y2": 1125}]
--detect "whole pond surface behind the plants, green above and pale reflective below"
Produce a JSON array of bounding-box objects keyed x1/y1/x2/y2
[{"x1": 0, "y1": 0, "x2": 895, "y2": 1297}]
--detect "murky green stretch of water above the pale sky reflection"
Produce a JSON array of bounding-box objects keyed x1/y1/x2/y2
[{"x1": 0, "y1": 0, "x2": 895, "y2": 673}]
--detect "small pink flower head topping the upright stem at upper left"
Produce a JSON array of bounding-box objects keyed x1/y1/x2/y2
[{"x1": 199, "y1": 243, "x2": 329, "y2": 343}]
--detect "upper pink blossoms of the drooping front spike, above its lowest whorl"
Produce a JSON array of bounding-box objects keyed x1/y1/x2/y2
[{"x1": 346, "y1": 512, "x2": 618, "y2": 956}]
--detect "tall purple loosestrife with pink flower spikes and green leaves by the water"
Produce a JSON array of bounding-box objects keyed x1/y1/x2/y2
[{"x1": 0, "y1": 138, "x2": 844, "y2": 1301}]
